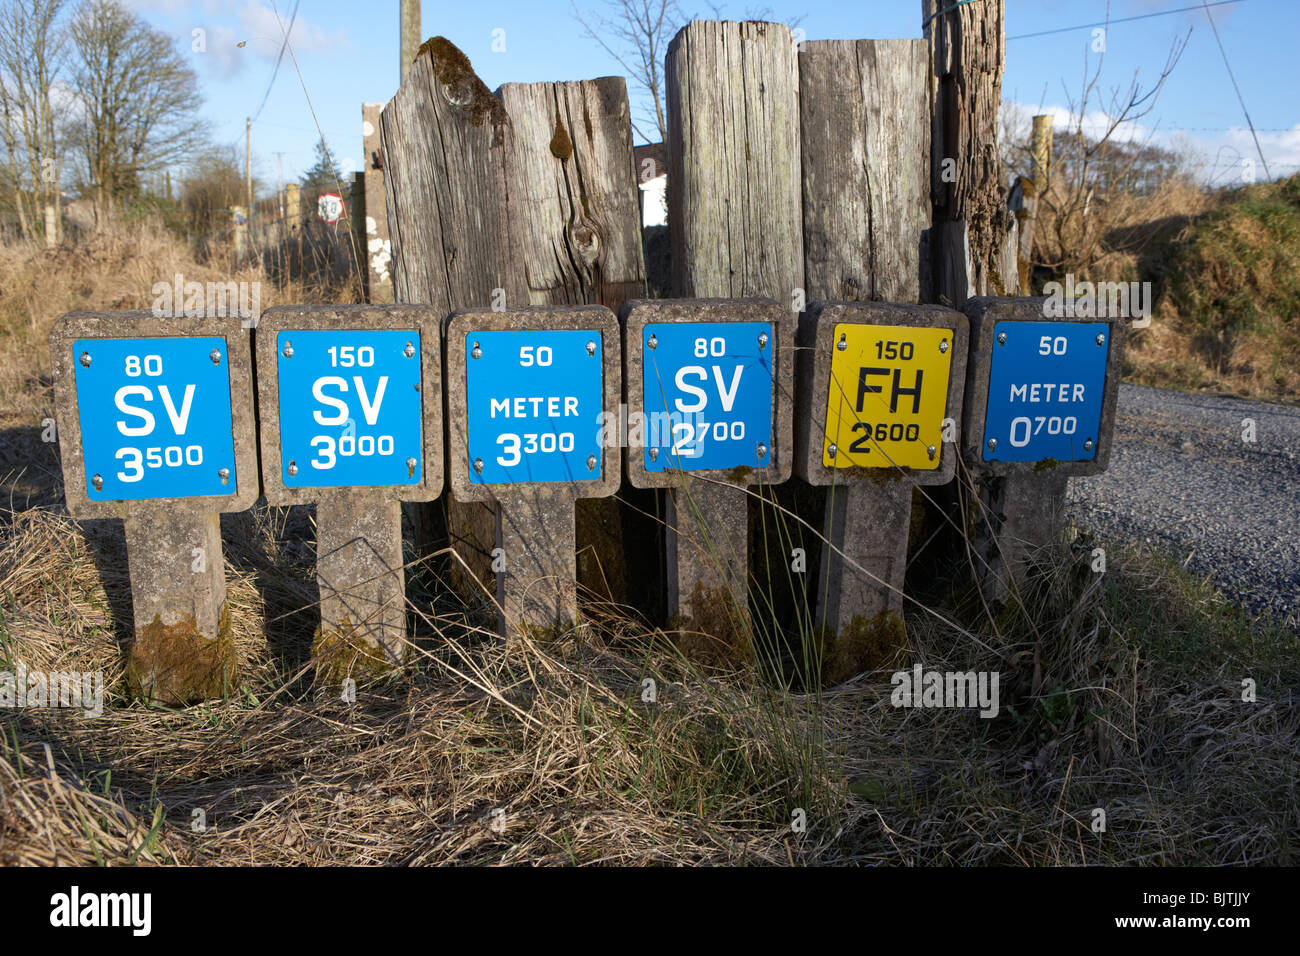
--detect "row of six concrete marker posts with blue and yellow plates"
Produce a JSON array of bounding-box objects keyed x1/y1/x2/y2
[{"x1": 51, "y1": 291, "x2": 1122, "y2": 702}]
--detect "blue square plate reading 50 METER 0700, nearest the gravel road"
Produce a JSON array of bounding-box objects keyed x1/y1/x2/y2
[{"x1": 983, "y1": 323, "x2": 1110, "y2": 462}]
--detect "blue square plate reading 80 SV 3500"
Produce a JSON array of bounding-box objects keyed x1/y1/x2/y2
[{"x1": 73, "y1": 336, "x2": 237, "y2": 501}]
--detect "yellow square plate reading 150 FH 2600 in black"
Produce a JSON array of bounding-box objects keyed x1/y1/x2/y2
[{"x1": 822, "y1": 324, "x2": 953, "y2": 471}]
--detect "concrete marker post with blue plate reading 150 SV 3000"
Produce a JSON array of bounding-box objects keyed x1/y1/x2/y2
[{"x1": 257, "y1": 306, "x2": 443, "y2": 687}]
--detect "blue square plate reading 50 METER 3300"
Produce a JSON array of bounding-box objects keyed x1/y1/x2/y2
[{"x1": 465, "y1": 329, "x2": 605, "y2": 485}]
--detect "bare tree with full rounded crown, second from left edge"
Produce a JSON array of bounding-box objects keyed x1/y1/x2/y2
[{"x1": 70, "y1": 0, "x2": 207, "y2": 219}]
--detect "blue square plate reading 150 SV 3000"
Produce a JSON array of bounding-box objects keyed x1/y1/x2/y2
[{"x1": 276, "y1": 329, "x2": 424, "y2": 488}]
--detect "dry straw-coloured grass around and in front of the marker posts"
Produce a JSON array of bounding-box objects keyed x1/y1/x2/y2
[{"x1": 0, "y1": 223, "x2": 1300, "y2": 865}]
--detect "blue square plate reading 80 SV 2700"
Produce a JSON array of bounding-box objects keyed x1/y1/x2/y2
[{"x1": 641, "y1": 323, "x2": 776, "y2": 471}]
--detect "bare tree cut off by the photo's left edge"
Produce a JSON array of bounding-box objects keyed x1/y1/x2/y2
[{"x1": 0, "y1": 0, "x2": 68, "y2": 238}]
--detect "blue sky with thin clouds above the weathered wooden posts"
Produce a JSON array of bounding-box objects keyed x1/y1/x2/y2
[{"x1": 126, "y1": 0, "x2": 1300, "y2": 195}]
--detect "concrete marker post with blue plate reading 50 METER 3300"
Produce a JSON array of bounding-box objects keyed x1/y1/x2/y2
[{"x1": 446, "y1": 306, "x2": 623, "y2": 637}]
